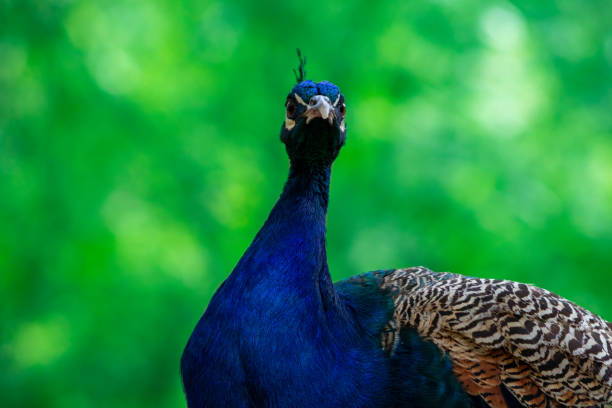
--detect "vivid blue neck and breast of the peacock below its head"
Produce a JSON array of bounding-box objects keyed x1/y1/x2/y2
[{"x1": 182, "y1": 163, "x2": 388, "y2": 408}]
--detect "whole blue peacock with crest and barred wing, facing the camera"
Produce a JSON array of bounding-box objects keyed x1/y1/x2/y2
[{"x1": 181, "y1": 58, "x2": 612, "y2": 408}]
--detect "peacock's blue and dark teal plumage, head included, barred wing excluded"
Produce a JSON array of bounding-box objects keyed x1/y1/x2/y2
[{"x1": 181, "y1": 81, "x2": 476, "y2": 408}]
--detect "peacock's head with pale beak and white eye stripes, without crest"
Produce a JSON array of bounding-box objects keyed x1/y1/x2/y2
[{"x1": 281, "y1": 81, "x2": 346, "y2": 166}]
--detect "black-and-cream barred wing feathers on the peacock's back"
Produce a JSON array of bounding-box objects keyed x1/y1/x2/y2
[{"x1": 379, "y1": 267, "x2": 612, "y2": 408}]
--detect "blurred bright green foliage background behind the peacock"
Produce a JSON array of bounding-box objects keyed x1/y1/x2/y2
[{"x1": 0, "y1": 0, "x2": 612, "y2": 408}]
